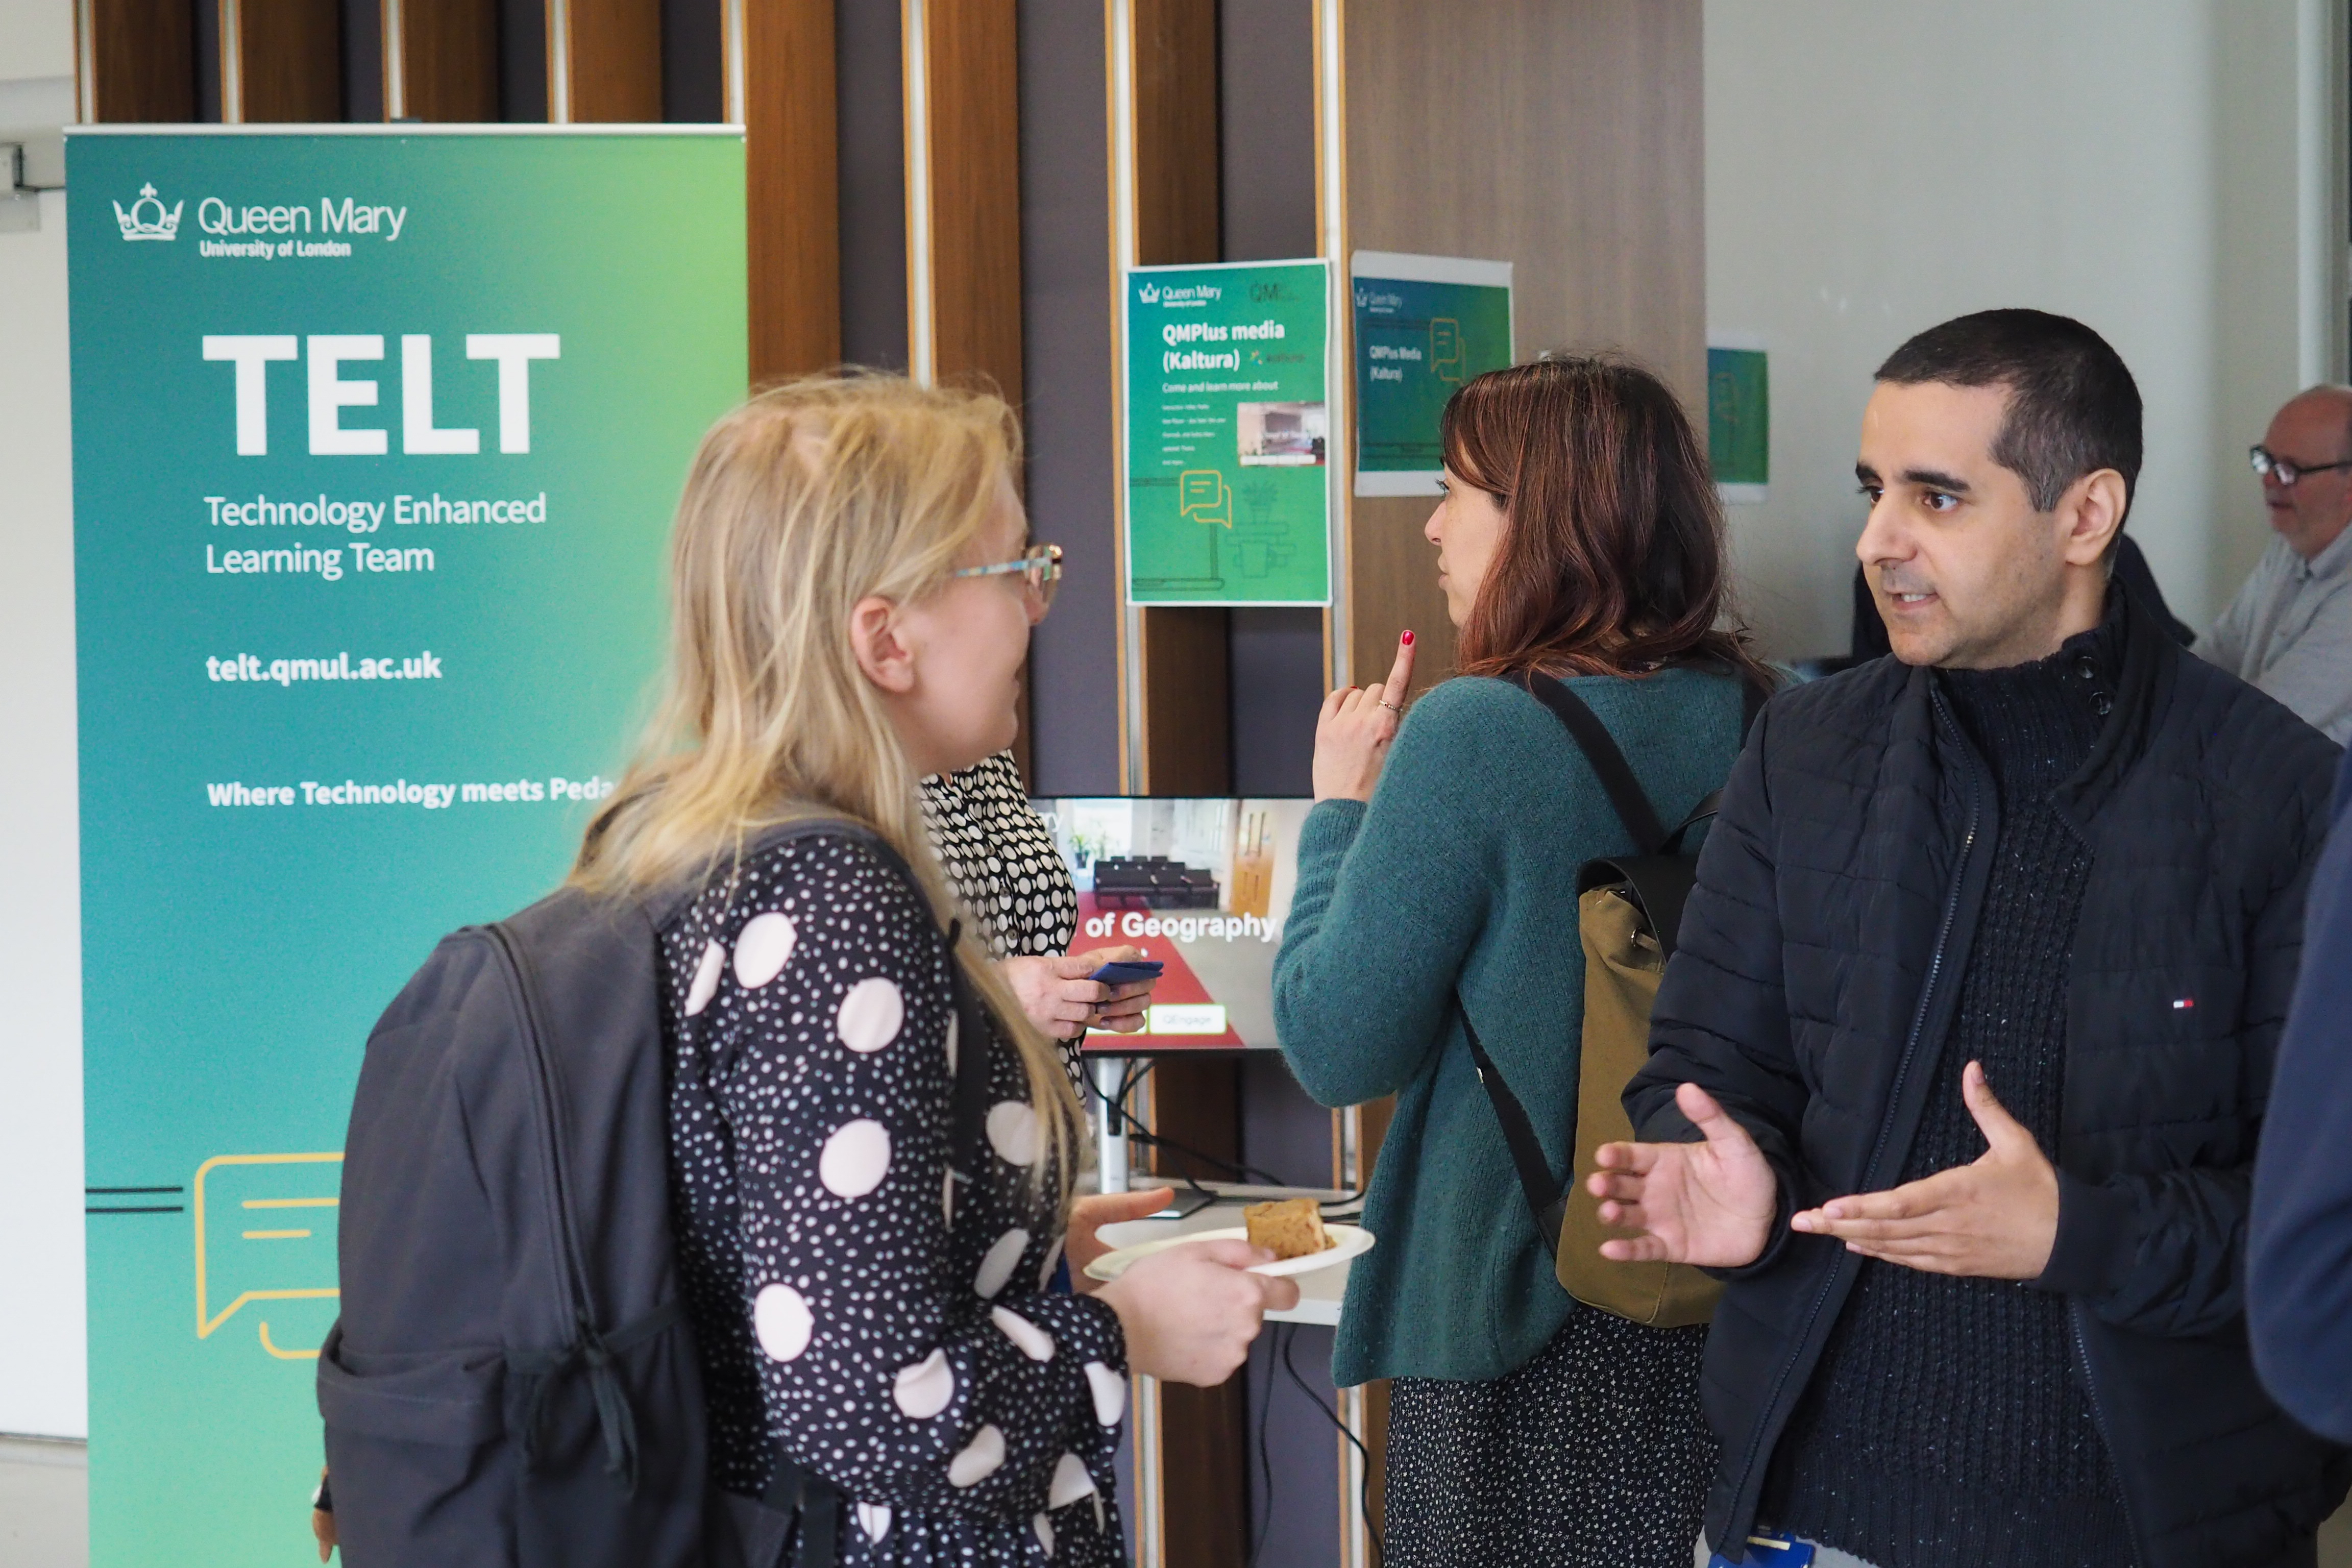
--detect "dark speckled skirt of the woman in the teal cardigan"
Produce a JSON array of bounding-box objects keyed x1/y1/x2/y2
[{"x1": 1385, "y1": 1307, "x2": 1714, "y2": 1568}]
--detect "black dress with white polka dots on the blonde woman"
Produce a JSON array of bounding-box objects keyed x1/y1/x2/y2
[{"x1": 663, "y1": 839, "x2": 1126, "y2": 1568}]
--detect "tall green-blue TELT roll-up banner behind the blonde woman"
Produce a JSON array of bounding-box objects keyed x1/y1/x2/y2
[{"x1": 66, "y1": 127, "x2": 746, "y2": 1568}]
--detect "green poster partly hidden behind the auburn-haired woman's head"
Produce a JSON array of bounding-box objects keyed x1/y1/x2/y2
[{"x1": 1348, "y1": 252, "x2": 1512, "y2": 496}]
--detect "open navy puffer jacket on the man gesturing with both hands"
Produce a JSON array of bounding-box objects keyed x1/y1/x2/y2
[{"x1": 1625, "y1": 592, "x2": 2352, "y2": 1568}]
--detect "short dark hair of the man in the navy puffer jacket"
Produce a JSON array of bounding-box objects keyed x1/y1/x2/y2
[{"x1": 1879, "y1": 310, "x2": 2140, "y2": 512}]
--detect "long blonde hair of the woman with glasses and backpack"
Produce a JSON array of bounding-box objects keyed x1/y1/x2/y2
[{"x1": 572, "y1": 372, "x2": 1082, "y2": 1192}]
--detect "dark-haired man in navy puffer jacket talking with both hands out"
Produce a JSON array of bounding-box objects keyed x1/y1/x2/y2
[{"x1": 1592, "y1": 310, "x2": 2352, "y2": 1568}]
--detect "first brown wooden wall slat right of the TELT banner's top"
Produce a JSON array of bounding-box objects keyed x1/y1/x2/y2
[{"x1": 727, "y1": 0, "x2": 842, "y2": 381}]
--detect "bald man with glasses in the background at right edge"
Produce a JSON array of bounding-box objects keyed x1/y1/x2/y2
[{"x1": 2197, "y1": 385, "x2": 2352, "y2": 745}]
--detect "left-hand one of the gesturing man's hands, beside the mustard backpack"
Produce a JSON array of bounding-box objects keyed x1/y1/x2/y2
[{"x1": 1585, "y1": 1084, "x2": 1780, "y2": 1269}]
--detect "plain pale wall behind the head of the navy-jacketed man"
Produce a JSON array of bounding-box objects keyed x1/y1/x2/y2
[{"x1": 1705, "y1": 0, "x2": 2343, "y2": 658}]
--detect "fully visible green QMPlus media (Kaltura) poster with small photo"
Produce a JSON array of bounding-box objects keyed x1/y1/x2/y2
[{"x1": 1126, "y1": 261, "x2": 1331, "y2": 604}]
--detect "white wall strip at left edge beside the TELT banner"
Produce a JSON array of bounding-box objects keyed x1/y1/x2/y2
[{"x1": 0, "y1": 0, "x2": 89, "y2": 1436}]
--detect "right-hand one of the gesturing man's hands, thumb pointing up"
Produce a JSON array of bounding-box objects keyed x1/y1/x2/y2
[{"x1": 1790, "y1": 1063, "x2": 2058, "y2": 1279}]
